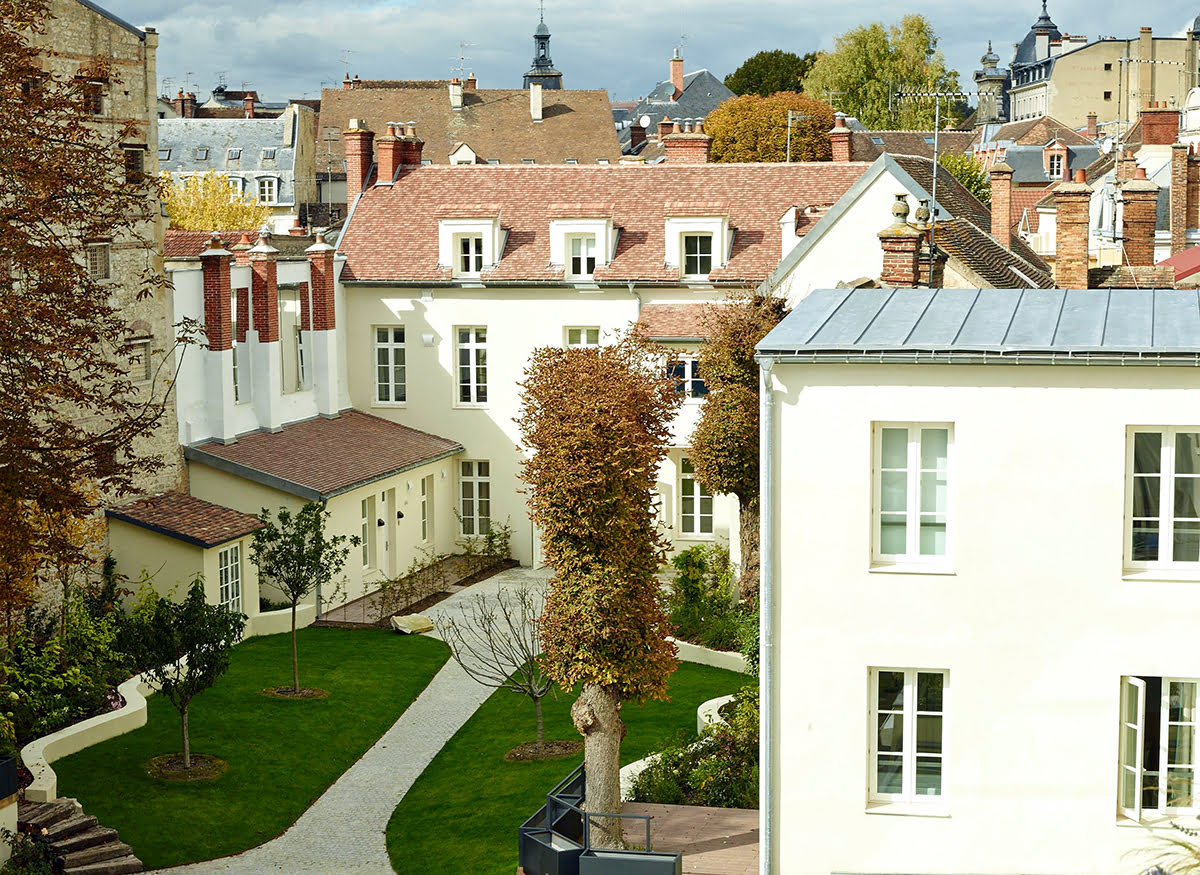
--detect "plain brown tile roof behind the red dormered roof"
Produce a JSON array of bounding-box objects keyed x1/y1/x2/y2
[{"x1": 317, "y1": 82, "x2": 620, "y2": 169}]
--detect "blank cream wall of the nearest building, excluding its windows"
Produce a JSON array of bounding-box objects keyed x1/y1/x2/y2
[{"x1": 773, "y1": 362, "x2": 1200, "y2": 875}]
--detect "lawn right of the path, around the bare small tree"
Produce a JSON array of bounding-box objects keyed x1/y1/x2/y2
[{"x1": 388, "y1": 664, "x2": 748, "y2": 875}]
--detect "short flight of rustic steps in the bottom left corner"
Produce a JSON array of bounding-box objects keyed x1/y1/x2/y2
[{"x1": 17, "y1": 799, "x2": 143, "y2": 875}]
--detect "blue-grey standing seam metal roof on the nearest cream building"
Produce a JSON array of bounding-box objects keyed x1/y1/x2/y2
[{"x1": 758, "y1": 288, "x2": 1200, "y2": 359}]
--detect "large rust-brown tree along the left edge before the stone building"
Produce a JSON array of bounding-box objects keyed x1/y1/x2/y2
[{"x1": 0, "y1": 0, "x2": 180, "y2": 588}]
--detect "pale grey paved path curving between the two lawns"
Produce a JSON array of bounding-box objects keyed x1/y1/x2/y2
[{"x1": 147, "y1": 568, "x2": 548, "y2": 875}]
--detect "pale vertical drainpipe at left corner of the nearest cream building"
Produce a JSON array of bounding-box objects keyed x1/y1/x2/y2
[{"x1": 758, "y1": 356, "x2": 778, "y2": 875}]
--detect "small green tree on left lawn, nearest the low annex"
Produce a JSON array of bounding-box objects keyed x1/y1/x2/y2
[{"x1": 250, "y1": 502, "x2": 352, "y2": 694}]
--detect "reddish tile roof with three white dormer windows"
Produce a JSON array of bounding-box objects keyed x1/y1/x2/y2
[{"x1": 338, "y1": 162, "x2": 868, "y2": 283}]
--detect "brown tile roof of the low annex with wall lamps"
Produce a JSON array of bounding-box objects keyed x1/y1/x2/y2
[{"x1": 184, "y1": 410, "x2": 462, "y2": 501}]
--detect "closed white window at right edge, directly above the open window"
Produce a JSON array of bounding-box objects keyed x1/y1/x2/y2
[{"x1": 1126, "y1": 427, "x2": 1200, "y2": 571}]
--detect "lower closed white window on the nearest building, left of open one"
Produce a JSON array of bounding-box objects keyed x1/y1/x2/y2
[{"x1": 869, "y1": 669, "x2": 950, "y2": 802}]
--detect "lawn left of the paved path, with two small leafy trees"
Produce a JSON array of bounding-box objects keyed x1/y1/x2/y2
[{"x1": 54, "y1": 629, "x2": 449, "y2": 869}]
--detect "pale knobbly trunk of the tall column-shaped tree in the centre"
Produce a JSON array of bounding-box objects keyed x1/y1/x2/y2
[{"x1": 571, "y1": 683, "x2": 625, "y2": 847}]
